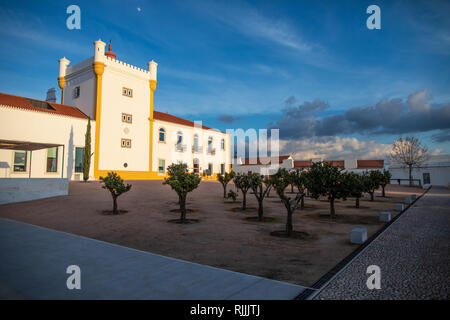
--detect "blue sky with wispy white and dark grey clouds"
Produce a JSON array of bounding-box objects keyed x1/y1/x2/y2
[{"x1": 0, "y1": 0, "x2": 450, "y2": 159}]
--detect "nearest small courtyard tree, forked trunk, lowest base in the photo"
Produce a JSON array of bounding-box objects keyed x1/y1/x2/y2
[{"x1": 270, "y1": 169, "x2": 302, "y2": 237}]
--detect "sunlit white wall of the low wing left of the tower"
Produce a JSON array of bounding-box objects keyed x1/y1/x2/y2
[{"x1": 0, "y1": 106, "x2": 95, "y2": 179}]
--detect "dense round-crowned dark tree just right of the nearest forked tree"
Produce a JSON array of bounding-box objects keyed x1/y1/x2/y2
[{"x1": 306, "y1": 162, "x2": 349, "y2": 218}]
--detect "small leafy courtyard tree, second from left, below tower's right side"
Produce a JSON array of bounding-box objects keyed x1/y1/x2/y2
[{"x1": 163, "y1": 163, "x2": 202, "y2": 223}]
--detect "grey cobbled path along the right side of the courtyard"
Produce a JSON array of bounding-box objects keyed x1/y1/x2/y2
[{"x1": 315, "y1": 187, "x2": 450, "y2": 300}]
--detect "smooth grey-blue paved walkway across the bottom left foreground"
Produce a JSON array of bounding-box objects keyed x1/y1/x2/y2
[{"x1": 0, "y1": 219, "x2": 304, "y2": 300}]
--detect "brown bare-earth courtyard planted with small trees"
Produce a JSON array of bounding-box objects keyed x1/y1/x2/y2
[{"x1": 0, "y1": 181, "x2": 423, "y2": 286}]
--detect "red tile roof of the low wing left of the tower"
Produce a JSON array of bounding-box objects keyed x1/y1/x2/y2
[{"x1": 0, "y1": 93, "x2": 88, "y2": 119}]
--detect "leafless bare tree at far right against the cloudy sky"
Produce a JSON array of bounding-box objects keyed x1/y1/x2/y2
[{"x1": 391, "y1": 136, "x2": 430, "y2": 186}]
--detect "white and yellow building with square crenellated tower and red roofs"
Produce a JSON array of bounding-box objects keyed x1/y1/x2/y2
[{"x1": 0, "y1": 40, "x2": 231, "y2": 186}]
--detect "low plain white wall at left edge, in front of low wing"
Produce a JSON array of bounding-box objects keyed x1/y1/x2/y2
[{"x1": 0, "y1": 178, "x2": 69, "y2": 204}]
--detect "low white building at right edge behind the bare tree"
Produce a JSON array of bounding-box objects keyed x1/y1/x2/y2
[{"x1": 389, "y1": 154, "x2": 450, "y2": 187}]
